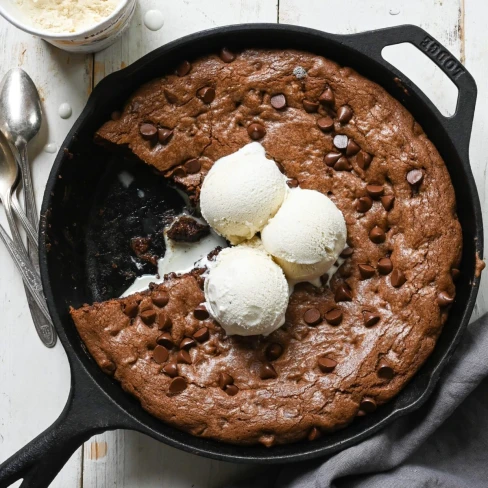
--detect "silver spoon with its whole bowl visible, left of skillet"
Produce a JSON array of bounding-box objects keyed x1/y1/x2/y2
[{"x1": 0, "y1": 68, "x2": 56, "y2": 347}]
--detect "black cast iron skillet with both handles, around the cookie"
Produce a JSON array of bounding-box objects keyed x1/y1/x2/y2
[{"x1": 0, "y1": 24, "x2": 483, "y2": 488}]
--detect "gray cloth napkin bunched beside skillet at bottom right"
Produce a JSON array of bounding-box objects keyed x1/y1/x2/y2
[{"x1": 234, "y1": 314, "x2": 488, "y2": 488}]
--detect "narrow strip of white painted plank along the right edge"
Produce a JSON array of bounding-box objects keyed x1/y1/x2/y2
[{"x1": 463, "y1": 0, "x2": 488, "y2": 320}]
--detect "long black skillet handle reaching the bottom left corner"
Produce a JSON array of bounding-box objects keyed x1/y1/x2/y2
[{"x1": 0, "y1": 359, "x2": 134, "y2": 488}]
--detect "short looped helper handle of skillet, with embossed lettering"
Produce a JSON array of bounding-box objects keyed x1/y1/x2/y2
[{"x1": 341, "y1": 25, "x2": 477, "y2": 156}]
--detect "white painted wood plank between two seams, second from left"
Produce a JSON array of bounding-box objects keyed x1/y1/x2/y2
[{"x1": 83, "y1": 0, "x2": 277, "y2": 488}]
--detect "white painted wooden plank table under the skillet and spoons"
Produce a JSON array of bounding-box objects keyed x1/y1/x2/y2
[{"x1": 0, "y1": 0, "x2": 488, "y2": 488}]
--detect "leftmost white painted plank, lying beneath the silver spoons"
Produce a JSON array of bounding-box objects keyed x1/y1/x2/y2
[{"x1": 0, "y1": 13, "x2": 92, "y2": 488}]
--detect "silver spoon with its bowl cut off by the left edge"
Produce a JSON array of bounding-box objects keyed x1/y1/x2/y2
[{"x1": 0, "y1": 132, "x2": 56, "y2": 347}]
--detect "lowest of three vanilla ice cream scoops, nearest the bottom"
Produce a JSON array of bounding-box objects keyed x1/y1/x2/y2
[{"x1": 204, "y1": 245, "x2": 288, "y2": 336}]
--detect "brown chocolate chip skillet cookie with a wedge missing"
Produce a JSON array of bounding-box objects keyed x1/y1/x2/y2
[{"x1": 71, "y1": 49, "x2": 461, "y2": 446}]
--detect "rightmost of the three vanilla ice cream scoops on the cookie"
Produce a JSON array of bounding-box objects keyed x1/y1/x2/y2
[{"x1": 261, "y1": 188, "x2": 347, "y2": 285}]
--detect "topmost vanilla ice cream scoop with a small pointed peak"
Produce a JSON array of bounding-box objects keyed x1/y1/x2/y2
[{"x1": 200, "y1": 142, "x2": 288, "y2": 244}]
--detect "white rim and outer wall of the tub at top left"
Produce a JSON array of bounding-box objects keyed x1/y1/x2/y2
[{"x1": 0, "y1": 0, "x2": 136, "y2": 53}]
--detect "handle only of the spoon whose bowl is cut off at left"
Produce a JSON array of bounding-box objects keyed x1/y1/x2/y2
[{"x1": 0, "y1": 191, "x2": 56, "y2": 347}]
